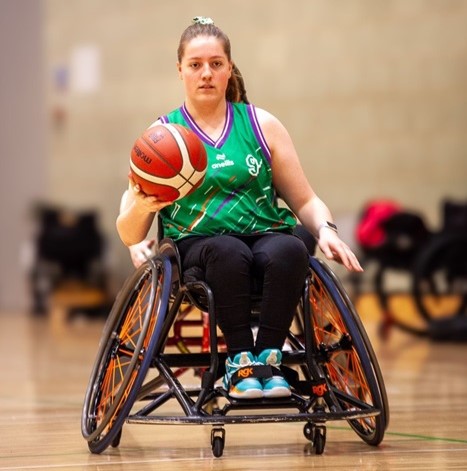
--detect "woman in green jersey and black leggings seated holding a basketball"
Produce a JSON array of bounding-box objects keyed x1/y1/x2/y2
[{"x1": 117, "y1": 17, "x2": 362, "y2": 399}]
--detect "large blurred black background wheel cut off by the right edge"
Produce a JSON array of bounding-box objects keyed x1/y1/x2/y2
[{"x1": 412, "y1": 234, "x2": 467, "y2": 322}]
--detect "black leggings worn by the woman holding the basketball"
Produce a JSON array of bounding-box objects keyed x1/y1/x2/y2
[{"x1": 178, "y1": 233, "x2": 309, "y2": 356}]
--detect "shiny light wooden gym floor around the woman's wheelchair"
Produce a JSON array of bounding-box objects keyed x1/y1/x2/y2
[{"x1": 0, "y1": 296, "x2": 467, "y2": 471}]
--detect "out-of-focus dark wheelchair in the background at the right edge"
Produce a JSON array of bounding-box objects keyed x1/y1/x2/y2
[{"x1": 361, "y1": 200, "x2": 467, "y2": 340}]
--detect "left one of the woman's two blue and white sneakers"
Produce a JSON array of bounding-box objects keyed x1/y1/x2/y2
[{"x1": 224, "y1": 352, "x2": 263, "y2": 399}]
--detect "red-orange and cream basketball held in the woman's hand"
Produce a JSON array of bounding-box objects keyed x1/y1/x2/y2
[{"x1": 130, "y1": 124, "x2": 207, "y2": 201}]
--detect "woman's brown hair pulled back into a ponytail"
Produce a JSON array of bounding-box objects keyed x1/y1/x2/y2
[{"x1": 177, "y1": 22, "x2": 249, "y2": 104}]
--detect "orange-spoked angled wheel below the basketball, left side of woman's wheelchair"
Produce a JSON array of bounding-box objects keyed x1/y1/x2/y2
[{"x1": 81, "y1": 257, "x2": 171, "y2": 453}]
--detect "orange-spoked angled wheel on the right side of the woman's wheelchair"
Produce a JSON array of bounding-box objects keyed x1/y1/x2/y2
[{"x1": 310, "y1": 257, "x2": 389, "y2": 445}]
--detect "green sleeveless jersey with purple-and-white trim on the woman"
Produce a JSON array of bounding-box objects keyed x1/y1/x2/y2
[{"x1": 160, "y1": 102, "x2": 296, "y2": 240}]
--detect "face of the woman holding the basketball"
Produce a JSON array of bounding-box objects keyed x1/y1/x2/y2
[{"x1": 177, "y1": 36, "x2": 232, "y2": 103}]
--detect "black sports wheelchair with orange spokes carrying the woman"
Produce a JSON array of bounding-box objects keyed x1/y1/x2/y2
[{"x1": 81, "y1": 239, "x2": 389, "y2": 457}]
